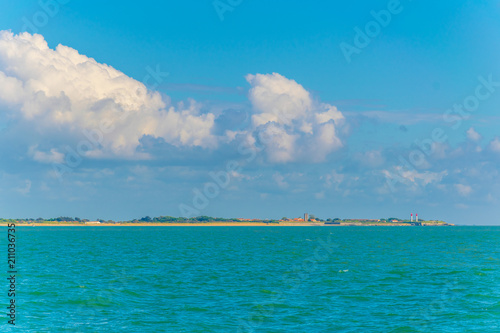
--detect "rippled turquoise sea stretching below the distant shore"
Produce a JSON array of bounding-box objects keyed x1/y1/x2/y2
[{"x1": 0, "y1": 226, "x2": 500, "y2": 332}]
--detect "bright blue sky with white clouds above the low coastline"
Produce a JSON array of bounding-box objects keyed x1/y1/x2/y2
[{"x1": 0, "y1": 0, "x2": 500, "y2": 224}]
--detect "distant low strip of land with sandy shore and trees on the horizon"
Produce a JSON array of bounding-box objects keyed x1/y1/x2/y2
[{"x1": 0, "y1": 214, "x2": 454, "y2": 226}]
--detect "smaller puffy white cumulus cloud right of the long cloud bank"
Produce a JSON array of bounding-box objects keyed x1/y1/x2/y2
[{"x1": 246, "y1": 73, "x2": 344, "y2": 163}]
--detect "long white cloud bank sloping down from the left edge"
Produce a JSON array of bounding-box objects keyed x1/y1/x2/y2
[{"x1": 0, "y1": 31, "x2": 216, "y2": 161}]
